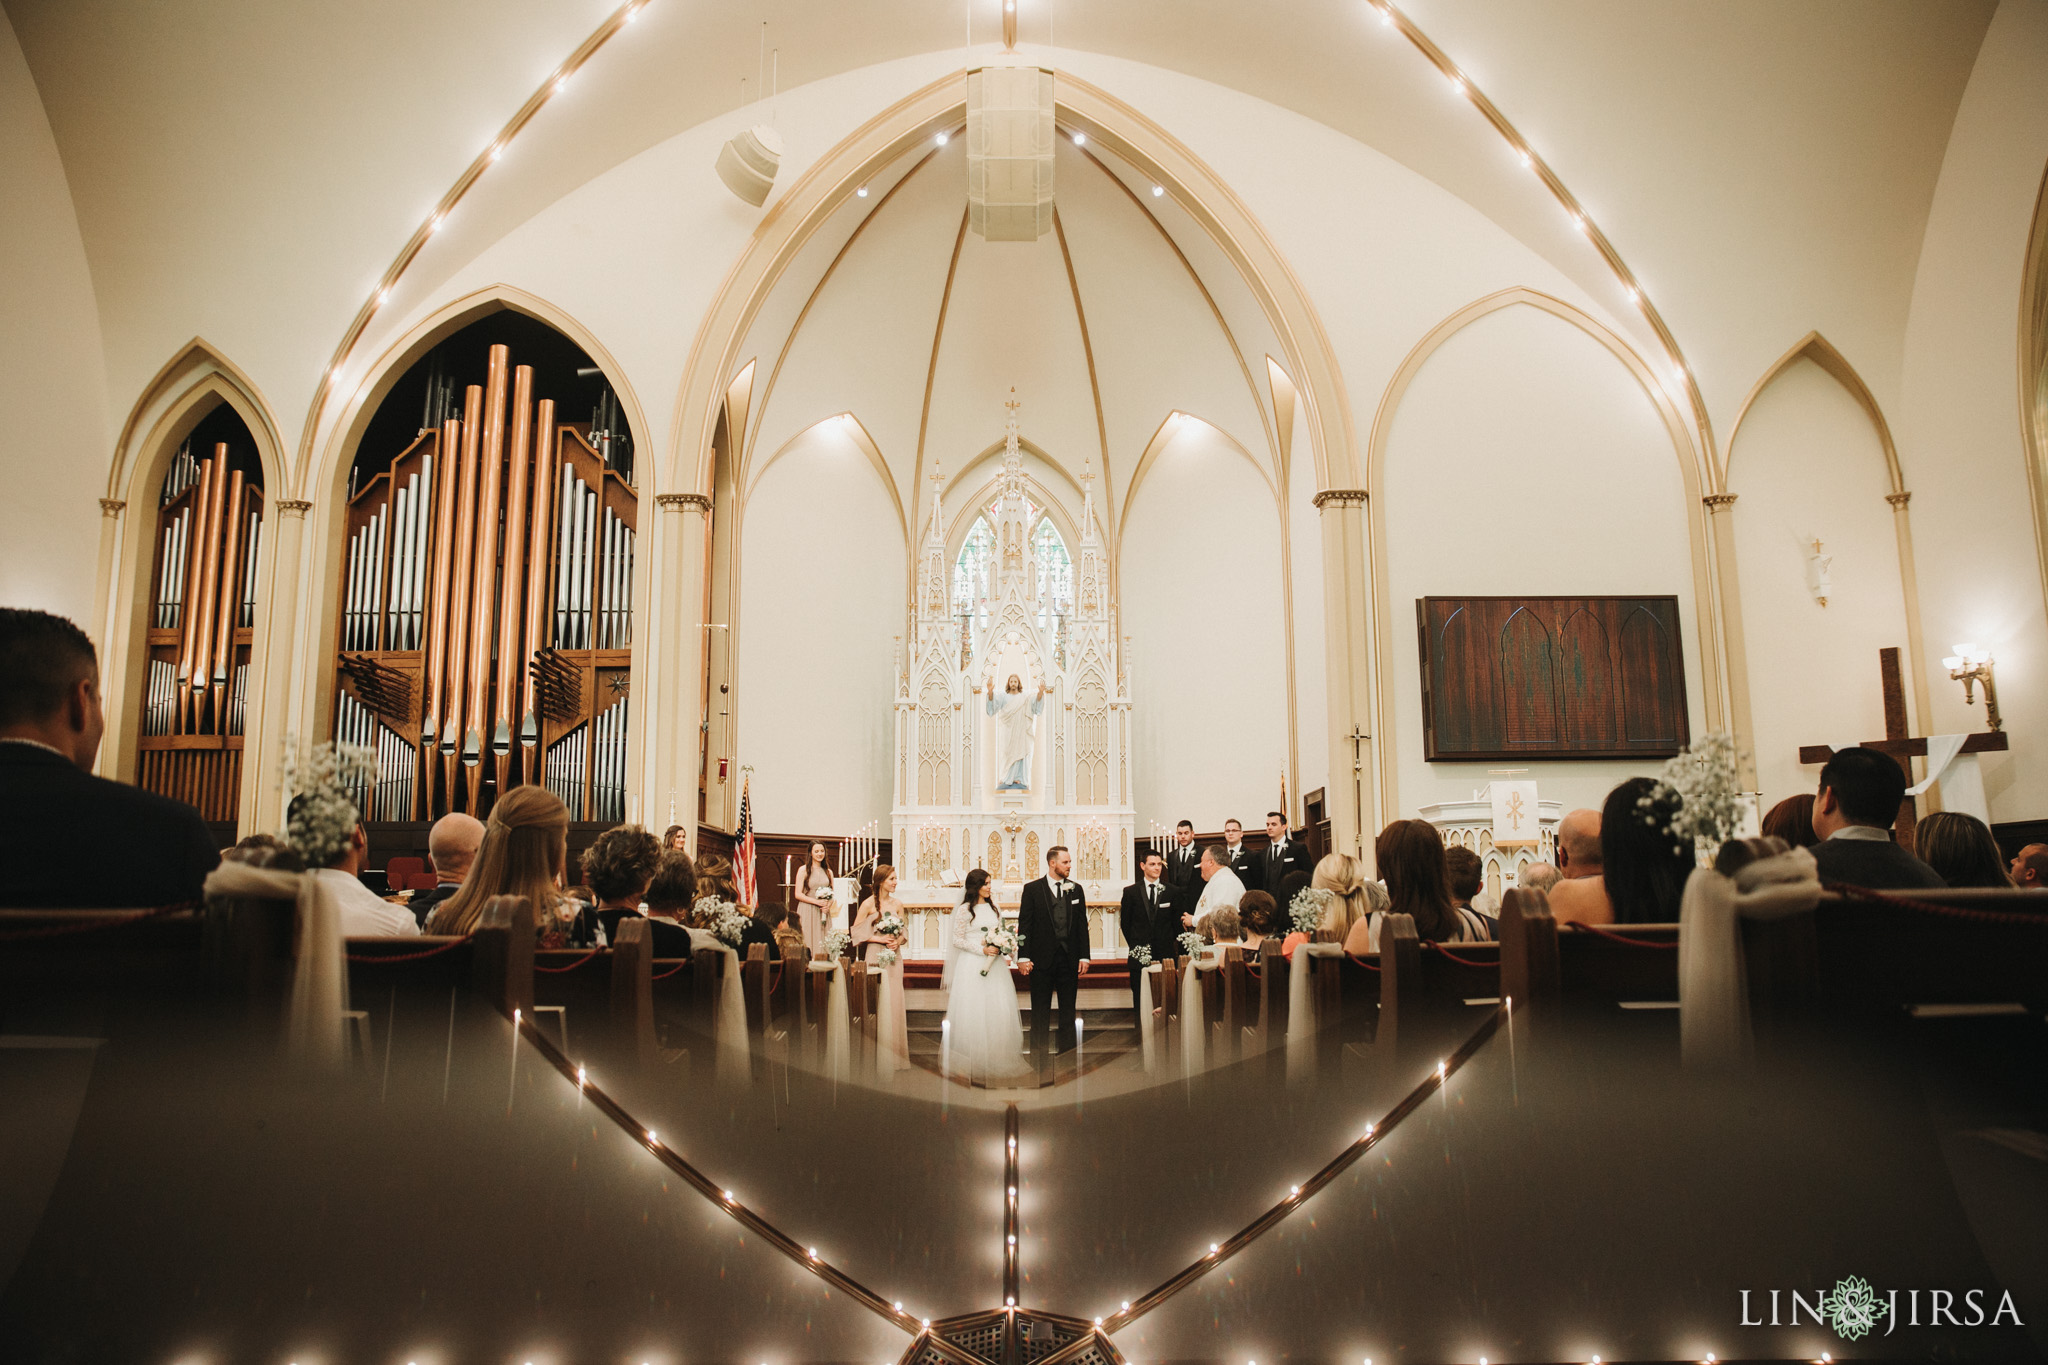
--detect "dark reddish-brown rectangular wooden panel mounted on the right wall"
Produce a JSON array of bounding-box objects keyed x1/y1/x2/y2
[{"x1": 1415, "y1": 598, "x2": 1692, "y2": 763}]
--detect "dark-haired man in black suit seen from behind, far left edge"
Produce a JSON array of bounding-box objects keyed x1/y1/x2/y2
[{"x1": 0, "y1": 608, "x2": 221, "y2": 911}]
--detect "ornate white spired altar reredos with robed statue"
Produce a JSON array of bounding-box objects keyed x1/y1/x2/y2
[{"x1": 891, "y1": 399, "x2": 1133, "y2": 925}]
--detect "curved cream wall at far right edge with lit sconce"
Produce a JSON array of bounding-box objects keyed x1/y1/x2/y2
[{"x1": 1892, "y1": 4, "x2": 2048, "y2": 821}]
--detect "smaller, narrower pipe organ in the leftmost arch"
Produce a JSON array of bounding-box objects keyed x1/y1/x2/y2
[{"x1": 135, "y1": 442, "x2": 262, "y2": 821}]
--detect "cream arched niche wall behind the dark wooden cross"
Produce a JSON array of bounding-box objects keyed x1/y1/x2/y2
[{"x1": 1729, "y1": 358, "x2": 1917, "y2": 808}]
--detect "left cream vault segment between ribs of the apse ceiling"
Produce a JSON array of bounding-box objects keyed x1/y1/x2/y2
[{"x1": 752, "y1": 139, "x2": 965, "y2": 503}]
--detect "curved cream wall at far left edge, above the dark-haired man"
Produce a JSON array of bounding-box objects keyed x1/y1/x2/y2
[{"x1": 0, "y1": 14, "x2": 113, "y2": 622}]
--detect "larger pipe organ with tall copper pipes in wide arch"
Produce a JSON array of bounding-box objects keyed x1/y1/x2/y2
[{"x1": 334, "y1": 346, "x2": 639, "y2": 823}]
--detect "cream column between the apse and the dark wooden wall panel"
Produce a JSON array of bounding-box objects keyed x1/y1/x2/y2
[{"x1": 1315, "y1": 489, "x2": 1376, "y2": 866}]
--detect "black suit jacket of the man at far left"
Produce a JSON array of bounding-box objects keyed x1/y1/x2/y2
[{"x1": 0, "y1": 743, "x2": 221, "y2": 911}]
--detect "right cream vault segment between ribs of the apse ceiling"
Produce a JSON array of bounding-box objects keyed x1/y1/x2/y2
[{"x1": 1061, "y1": 140, "x2": 1264, "y2": 524}]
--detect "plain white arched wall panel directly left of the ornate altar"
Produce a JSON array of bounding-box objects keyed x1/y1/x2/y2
[{"x1": 733, "y1": 424, "x2": 905, "y2": 831}]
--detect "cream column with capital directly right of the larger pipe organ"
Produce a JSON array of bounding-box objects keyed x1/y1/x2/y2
[{"x1": 663, "y1": 493, "x2": 711, "y2": 855}]
